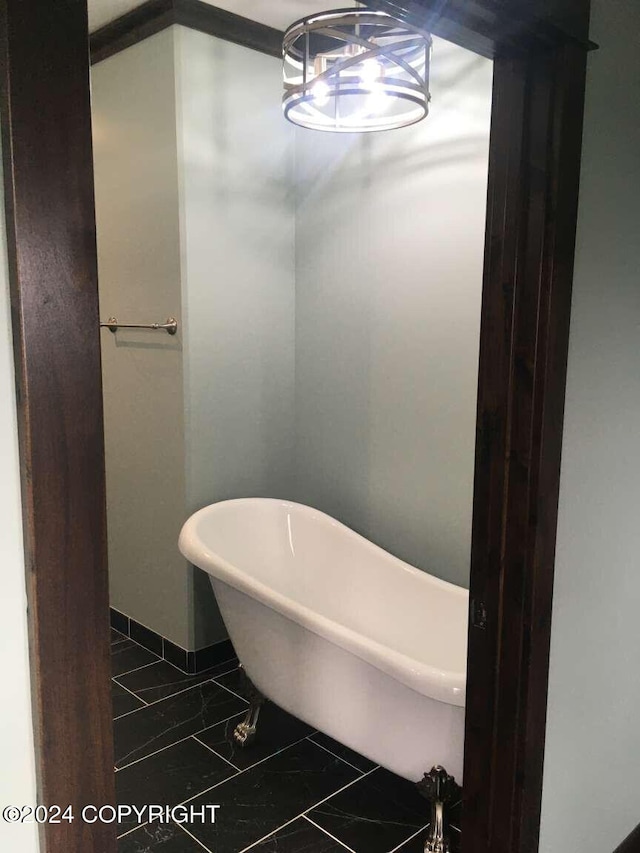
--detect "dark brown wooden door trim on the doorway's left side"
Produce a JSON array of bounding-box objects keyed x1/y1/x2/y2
[{"x1": 0, "y1": 0, "x2": 115, "y2": 853}]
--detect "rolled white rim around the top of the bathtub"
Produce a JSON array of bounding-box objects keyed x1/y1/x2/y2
[{"x1": 178, "y1": 498, "x2": 468, "y2": 707}]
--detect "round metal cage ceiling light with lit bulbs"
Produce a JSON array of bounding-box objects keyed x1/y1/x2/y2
[{"x1": 283, "y1": 7, "x2": 431, "y2": 133}]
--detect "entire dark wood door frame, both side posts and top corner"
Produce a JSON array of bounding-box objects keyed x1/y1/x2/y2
[{"x1": 0, "y1": 0, "x2": 589, "y2": 853}]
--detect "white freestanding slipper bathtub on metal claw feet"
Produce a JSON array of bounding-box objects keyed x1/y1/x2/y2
[{"x1": 179, "y1": 498, "x2": 468, "y2": 784}]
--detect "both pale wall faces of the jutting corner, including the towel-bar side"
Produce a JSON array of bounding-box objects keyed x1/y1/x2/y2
[{"x1": 92, "y1": 27, "x2": 295, "y2": 649}]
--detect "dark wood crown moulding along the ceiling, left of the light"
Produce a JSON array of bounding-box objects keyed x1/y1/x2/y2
[{"x1": 91, "y1": 0, "x2": 283, "y2": 64}]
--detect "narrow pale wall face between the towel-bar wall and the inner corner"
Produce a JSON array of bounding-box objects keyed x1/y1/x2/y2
[{"x1": 174, "y1": 27, "x2": 295, "y2": 646}]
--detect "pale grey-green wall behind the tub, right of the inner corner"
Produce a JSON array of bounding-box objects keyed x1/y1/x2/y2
[{"x1": 296, "y1": 39, "x2": 493, "y2": 585}]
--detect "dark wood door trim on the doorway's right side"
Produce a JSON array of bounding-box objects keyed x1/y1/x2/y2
[{"x1": 377, "y1": 0, "x2": 591, "y2": 853}]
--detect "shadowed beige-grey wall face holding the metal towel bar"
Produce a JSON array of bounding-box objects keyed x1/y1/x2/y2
[{"x1": 92, "y1": 30, "x2": 193, "y2": 648}]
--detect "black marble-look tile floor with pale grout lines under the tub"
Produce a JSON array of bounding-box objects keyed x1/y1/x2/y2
[{"x1": 111, "y1": 631, "x2": 450, "y2": 853}]
